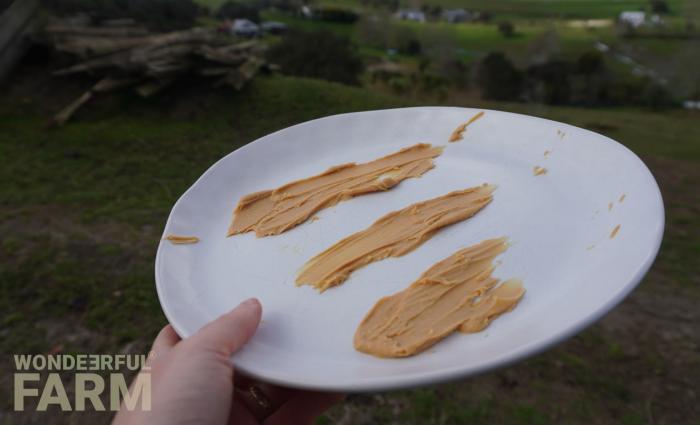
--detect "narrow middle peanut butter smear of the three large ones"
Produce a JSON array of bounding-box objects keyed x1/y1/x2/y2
[{"x1": 296, "y1": 184, "x2": 495, "y2": 292}]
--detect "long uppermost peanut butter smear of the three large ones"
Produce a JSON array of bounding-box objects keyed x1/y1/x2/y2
[{"x1": 228, "y1": 143, "x2": 443, "y2": 237}]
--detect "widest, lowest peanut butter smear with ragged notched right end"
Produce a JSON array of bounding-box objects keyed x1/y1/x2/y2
[{"x1": 354, "y1": 238, "x2": 525, "y2": 357}]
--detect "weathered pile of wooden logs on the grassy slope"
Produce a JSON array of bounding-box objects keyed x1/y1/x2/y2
[{"x1": 46, "y1": 19, "x2": 264, "y2": 125}]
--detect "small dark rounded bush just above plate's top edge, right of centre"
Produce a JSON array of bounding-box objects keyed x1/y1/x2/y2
[{"x1": 478, "y1": 52, "x2": 523, "y2": 100}]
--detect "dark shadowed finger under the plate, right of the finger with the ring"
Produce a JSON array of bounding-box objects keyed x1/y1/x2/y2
[{"x1": 265, "y1": 391, "x2": 343, "y2": 425}]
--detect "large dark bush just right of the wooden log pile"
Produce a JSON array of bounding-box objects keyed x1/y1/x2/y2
[{"x1": 268, "y1": 31, "x2": 363, "y2": 85}]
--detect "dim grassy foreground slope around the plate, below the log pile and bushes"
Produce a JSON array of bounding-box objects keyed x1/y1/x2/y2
[{"x1": 0, "y1": 66, "x2": 700, "y2": 425}]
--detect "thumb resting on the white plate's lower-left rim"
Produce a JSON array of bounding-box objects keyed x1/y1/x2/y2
[{"x1": 190, "y1": 298, "x2": 262, "y2": 356}]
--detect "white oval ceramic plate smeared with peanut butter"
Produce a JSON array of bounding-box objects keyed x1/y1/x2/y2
[{"x1": 155, "y1": 107, "x2": 664, "y2": 391}]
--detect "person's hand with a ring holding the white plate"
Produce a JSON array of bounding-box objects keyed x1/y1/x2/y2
[{"x1": 113, "y1": 299, "x2": 342, "y2": 425}]
